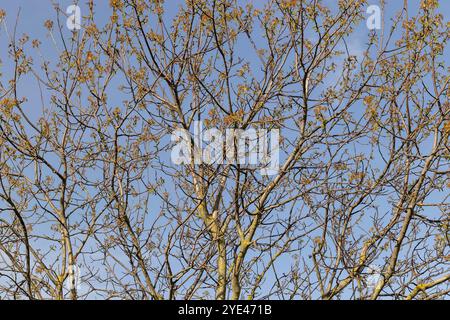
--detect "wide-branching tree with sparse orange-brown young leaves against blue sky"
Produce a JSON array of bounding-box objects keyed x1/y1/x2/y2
[{"x1": 0, "y1": 0, "x2": 450, "y2": 299}]
